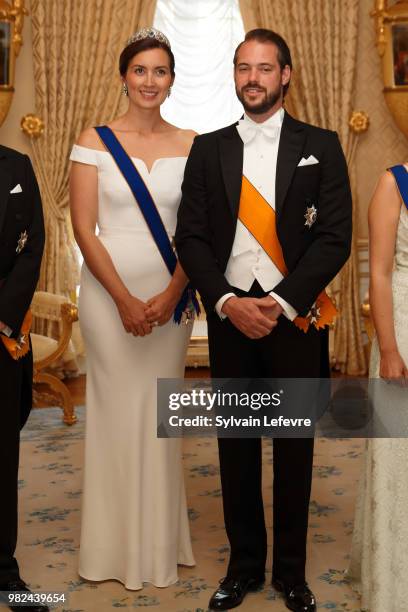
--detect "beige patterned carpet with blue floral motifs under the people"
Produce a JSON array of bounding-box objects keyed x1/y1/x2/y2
[{"x1": 9, "y1": 408, "x2": 362, "y2": 612}]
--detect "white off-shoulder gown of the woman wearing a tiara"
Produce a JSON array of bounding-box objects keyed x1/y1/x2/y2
[{"x1": 71, "y1": 145, "x2": 194, "y2": 589}]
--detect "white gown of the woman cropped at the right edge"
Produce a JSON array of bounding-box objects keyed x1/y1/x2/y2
[{"x1": 348, "y1": 200, "x2": 408, "y2": 612}]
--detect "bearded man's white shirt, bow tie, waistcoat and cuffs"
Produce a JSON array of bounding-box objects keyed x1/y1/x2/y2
[{"x1": 215, "y1": 108, "x2": 297, "y2": 321}]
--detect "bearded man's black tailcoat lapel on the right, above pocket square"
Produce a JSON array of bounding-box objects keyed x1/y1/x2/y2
[{"x1": 275, "y1": 112, "x2": 306, "y2": 216}]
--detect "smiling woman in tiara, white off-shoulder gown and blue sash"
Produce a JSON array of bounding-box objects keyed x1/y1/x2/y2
[{"x1": 70, "y1": 29, "x2": 195, "y2": 589}]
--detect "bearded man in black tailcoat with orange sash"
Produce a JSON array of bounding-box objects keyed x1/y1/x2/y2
[{"x1": 176, "y1": 29, "x2": 352, "y2": 612}]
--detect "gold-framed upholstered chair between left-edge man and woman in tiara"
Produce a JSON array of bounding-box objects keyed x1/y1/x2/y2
[{"x1": 31, "y1": 291, "x2": 78, "y2": 425}]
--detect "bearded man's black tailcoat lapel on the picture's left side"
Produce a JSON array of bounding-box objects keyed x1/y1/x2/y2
[{"x1": 219, "y1": 124, "x2": 244, "y2": 220}]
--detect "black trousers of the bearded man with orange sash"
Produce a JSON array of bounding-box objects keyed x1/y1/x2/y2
[{"x1": 208, "y1": 282, "x2": 327, "y2": 584}]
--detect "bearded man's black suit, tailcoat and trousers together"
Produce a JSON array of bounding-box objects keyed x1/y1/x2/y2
[{"x1": 176, "y1": 113, "x2": 352, "y2": 585}]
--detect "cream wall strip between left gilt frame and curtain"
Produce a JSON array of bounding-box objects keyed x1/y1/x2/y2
[{"x1": 0, "y1": 0, "x2": 35, "y2": 154}]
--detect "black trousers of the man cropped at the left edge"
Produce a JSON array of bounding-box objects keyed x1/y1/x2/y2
[{"x1": 0, "y1": 339, "x2": 32, "y2": 586}]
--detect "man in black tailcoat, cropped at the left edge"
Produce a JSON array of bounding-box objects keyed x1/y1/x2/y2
[{"x1": 0, "y1": 145, "x2": 48, "y2": 612}]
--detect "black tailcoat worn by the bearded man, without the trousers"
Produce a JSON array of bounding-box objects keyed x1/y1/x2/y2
[{"x1": 176, "y1": 113, "x2": 352, "y2": 315}]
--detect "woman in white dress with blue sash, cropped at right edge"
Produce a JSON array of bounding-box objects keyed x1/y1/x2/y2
[{"x1": 348, "y1": 164, "x2": 408, "y2": 612}]
